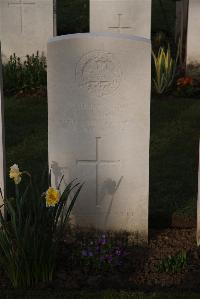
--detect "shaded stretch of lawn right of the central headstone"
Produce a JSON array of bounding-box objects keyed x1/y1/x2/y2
[{"x1": 150, "y1": 98, "x2": 200, "y2": 219}]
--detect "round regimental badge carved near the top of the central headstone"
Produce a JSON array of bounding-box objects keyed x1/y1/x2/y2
[{"x1": 76, "y1": 51, "x2": 122, "y2": 97}]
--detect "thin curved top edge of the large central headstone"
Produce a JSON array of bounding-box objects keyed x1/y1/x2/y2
[{"x1": 48, "y1": 32, "x2": 151, "y2": 44}]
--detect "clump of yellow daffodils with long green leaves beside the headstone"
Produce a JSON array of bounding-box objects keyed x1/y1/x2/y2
[{"x1": 0, "y1": 164, "x2": 82, "y2": 288}]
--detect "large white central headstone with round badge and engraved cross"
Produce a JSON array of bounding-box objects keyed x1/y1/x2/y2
[{"x1": 47, "y1": 34, "x2": 151, "y2": 241}]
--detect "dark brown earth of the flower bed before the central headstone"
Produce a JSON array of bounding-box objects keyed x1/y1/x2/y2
[{"x1": 0, "y1": 228, "x2": 200, "y2": 291}]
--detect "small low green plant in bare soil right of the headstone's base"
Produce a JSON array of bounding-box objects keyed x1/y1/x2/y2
[{"x1": 157, "y1": 251, "x2": 187, "y2": 273}]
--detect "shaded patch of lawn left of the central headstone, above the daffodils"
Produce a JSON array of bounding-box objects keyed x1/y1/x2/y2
[{"x1": 5, "y1": 97, "x2": 48, "y2": 195}]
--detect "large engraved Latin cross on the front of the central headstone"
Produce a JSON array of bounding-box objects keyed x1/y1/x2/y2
[{"x1": 76, "y1": 137, "x2": 120, "y2": 207}]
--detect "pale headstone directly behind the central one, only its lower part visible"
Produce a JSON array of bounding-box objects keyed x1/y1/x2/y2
[{"x1": 90, "y1": 0, "x2": 151, "y2": 39}]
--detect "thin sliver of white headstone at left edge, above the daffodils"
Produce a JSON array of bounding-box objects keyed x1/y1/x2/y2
[{"x1": 0, "y1": 44, "x2": 6, "y2": 205}]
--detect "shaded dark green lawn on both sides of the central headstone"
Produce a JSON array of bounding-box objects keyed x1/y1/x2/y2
[{"x1": 5, "y1": 97, "x2": 200, "y2": 223}]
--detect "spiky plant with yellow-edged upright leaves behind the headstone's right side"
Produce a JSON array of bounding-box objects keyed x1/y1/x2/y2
[{"x1": 152, "y1": 46, "x2": 179, "y2": 94}]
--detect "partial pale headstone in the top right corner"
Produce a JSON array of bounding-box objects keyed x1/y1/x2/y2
[{"x1": 187, "y1": 0, "x2": 200, "y2": 72}]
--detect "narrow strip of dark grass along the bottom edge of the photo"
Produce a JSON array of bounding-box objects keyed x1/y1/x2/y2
[{"x1": 0, "y1": 290, "x2": 200, "y2": 299}]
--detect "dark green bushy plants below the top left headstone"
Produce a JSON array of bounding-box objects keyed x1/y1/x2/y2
[{"x1": 3, "y1": 52, "x2": 47, "y2": 94}]
